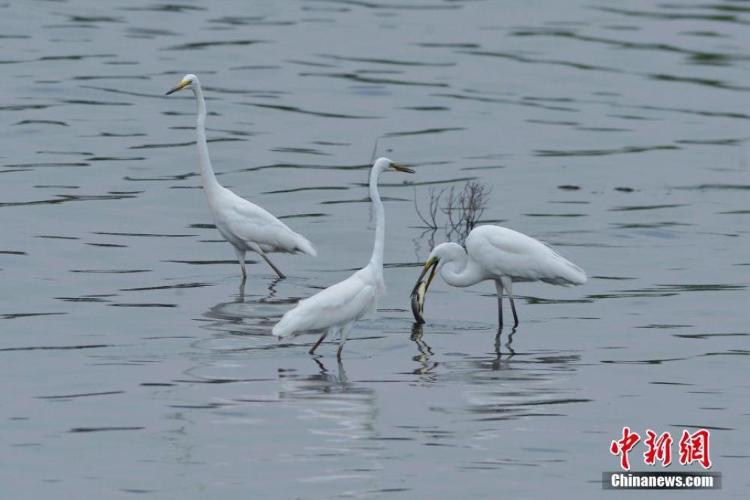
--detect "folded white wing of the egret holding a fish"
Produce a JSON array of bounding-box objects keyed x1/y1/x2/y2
[{"x1": 466, "y1": 225, "x2": 586, "y2": 285}]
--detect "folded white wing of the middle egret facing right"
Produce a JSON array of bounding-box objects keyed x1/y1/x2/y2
[{"x1": 273, "y1": 268, "x2": 377, "y2": 337}]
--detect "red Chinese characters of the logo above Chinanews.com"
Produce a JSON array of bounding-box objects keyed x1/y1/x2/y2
[{"x1": 609, "y1": 427, "x2": 711, "y2": 470}]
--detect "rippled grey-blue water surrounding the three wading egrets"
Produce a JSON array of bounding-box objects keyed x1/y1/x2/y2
[{"x1": 0, "y1": 0, "x2": 750, "y2": 499}]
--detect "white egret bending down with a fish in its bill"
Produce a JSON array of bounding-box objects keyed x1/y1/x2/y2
[{"x1": 411, "y1": 225, "x2": 586, "y2": 327}]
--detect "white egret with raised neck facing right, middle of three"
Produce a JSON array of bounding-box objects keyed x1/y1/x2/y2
[{"x1": 272, "y1": 158, "x2": 414, "y2": 359}]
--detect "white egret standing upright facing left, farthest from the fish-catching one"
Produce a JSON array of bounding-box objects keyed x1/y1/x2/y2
[{"x1": 166, "y1": 75, "x2": 317, "y2": 283}]
